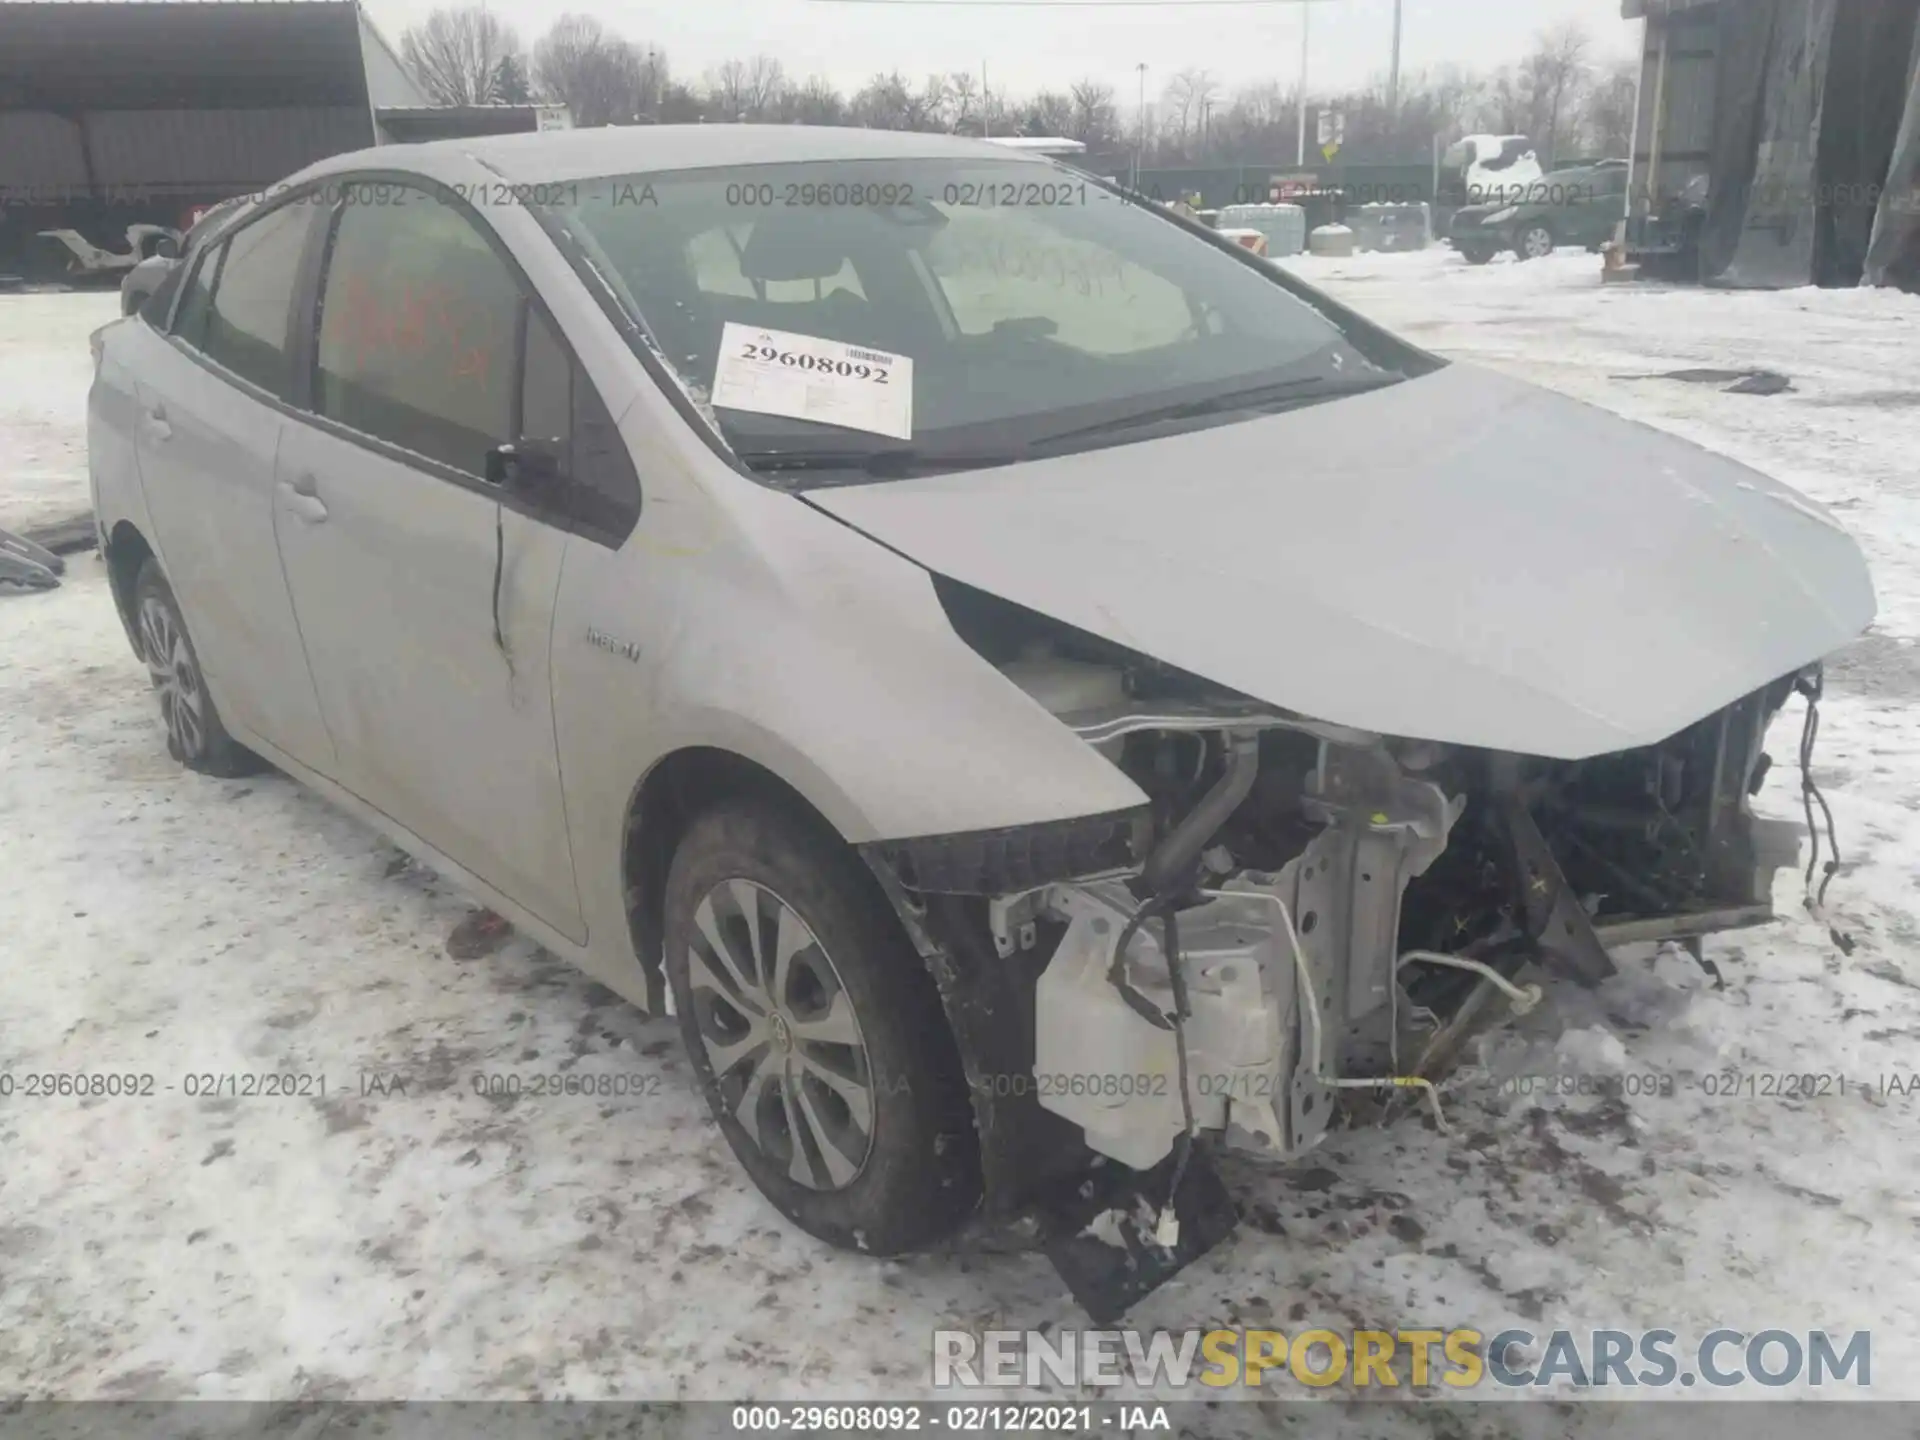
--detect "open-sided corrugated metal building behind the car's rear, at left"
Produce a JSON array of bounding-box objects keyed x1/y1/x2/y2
[{"x1": 0, "y1": 0, "x2": 564, "y2": 269}]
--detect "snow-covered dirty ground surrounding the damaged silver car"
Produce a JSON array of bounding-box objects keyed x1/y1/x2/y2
[{"x1": 0, "y1": 252, "x2": 1920, "y2": 1436}]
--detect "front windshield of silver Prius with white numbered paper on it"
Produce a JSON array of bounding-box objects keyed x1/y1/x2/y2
[{"x1": 547, "y1": 159, "x2": 1419, "y2": 470}]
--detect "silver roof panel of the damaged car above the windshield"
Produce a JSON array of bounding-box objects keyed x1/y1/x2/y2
[{"x1": 307, "y1": 125, "x2": 1052, "y2": 184}]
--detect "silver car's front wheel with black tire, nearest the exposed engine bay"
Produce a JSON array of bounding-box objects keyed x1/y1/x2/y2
[{"x1": 664, "y1": 801, "x2": 981, "y2": 1256}]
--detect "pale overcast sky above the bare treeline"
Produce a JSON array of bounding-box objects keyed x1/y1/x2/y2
[{"x1": 367, "y1": 0, "x2": 1640, "y2": 109}]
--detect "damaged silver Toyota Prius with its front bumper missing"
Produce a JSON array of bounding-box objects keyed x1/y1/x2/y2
[{"x1": 90, "y1": 125, "x2": 1874, "y2": 1313}]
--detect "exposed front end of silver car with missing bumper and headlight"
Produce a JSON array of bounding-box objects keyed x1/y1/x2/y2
[{"x1": 868, "y1": 582, "x2": 1818, "y2": 1317}]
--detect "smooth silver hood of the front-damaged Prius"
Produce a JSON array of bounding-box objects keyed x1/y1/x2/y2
[{"x1": 806, "y1": 365, "x2": 1874, "y2": 758}]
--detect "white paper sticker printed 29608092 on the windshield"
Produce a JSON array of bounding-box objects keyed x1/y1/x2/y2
[{"x1": 712, "y1": 321, "x2": 914, "y2": 440}]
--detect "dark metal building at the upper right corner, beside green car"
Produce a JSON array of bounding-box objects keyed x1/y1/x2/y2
[{"x1": 1622, "y1": 0, "x2": 1920, "y2": 288}]
